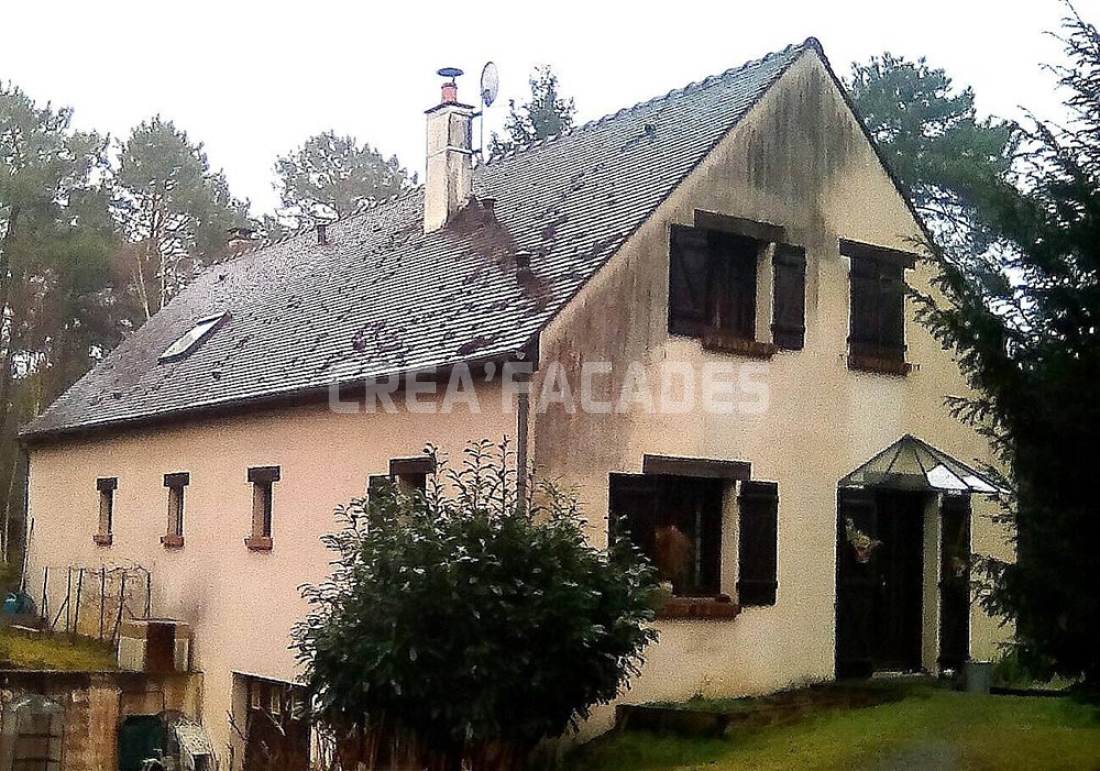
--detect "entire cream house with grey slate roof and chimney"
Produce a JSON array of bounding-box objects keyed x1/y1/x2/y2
[{"x1": 22, "y1": 38, "x2": 1009, "y2": 768}]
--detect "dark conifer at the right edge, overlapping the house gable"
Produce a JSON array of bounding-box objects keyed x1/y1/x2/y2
[{"x1": 919, "y1": 7, "x2": 1100, "y2": 690}]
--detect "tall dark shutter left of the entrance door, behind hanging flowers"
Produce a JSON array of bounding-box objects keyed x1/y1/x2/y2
[{"x1": 836, "y1": 488, "x2": 879, "y2": 678}]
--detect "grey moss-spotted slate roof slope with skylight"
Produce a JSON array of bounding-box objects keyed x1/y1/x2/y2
[{"x1": 23, "y1": 38, "x2": 821, "y2": 439}]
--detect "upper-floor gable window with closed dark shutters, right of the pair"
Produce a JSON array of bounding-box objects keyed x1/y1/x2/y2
[{"x1": 840, "y1": 241, "x2": 913, "y2": 374}]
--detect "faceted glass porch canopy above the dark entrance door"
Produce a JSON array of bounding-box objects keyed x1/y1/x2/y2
[{"x1": 838, "y1": 433, "x2": 1001, "y2": 495}]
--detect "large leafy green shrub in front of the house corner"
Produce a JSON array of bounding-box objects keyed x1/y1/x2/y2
[{"x1": 296, "y1": 443, "x2": 656, "y2": 771}]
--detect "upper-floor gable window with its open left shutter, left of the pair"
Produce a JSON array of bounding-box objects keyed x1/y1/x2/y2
[{"x1": 669, "y1": 225, "x2": 762, "y2": 341}]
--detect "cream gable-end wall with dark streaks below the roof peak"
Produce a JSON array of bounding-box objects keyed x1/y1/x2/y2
[{"x1": 532, "y1": 54, "x2": 1005, "y2": 725}]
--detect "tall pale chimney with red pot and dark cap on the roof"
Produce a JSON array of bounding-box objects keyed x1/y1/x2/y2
[{"x1": 424, "y1": 67, "x2": 474, "y2": 233}]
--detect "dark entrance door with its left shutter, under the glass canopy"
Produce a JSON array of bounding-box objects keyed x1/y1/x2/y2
[{"x1": 836, "y1": 488, "x2": 925, "y2": 678}]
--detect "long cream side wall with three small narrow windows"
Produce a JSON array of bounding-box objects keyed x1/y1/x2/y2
[{"x1": 28, "y1": 384, "x2": 516, "y2": 757}]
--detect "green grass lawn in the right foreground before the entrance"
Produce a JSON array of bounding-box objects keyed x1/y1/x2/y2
[{"x1": 570, "y1": 687, "x2": 1100, "y2": 771}]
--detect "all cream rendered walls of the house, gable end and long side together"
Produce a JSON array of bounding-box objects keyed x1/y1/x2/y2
[{"x1": 29, "y1": 45, "x2": 1004, "y2": 748}]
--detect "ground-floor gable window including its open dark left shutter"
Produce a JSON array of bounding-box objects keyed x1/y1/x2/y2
[{"x1": 609, "y1": 474, "x2": 725, "y2": 597}]
